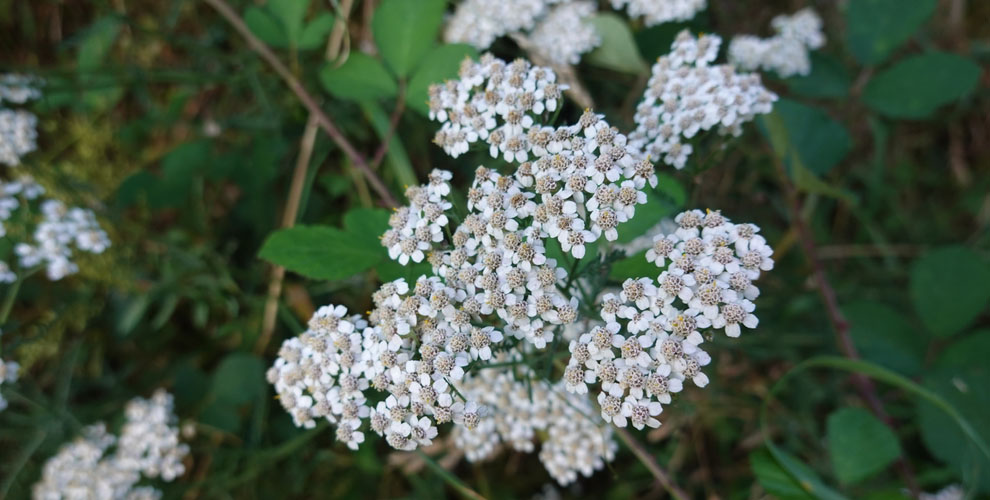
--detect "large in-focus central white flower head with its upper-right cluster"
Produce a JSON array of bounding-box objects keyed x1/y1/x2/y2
[{"x1": 268, "y1": 32, "x2": 775, "y2": 484}]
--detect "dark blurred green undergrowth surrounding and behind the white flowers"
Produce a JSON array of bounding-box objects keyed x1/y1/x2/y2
[{"x1": 0, "y1": 0, "x2": 990, "y2": 499}]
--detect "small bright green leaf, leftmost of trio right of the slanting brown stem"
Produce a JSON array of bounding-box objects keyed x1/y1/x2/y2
[{"x1": 320, "y1": 52, "x2": 398, "y2": 101}]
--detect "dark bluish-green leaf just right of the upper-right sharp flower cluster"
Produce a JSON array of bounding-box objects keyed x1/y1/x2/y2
[{"x1": 774, "y1": 99, "x2": 852, "y2": 176}]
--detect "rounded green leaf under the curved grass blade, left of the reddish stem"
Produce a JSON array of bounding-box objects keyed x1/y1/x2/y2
[{"x1": 826, "y1": 408, "x2": 901, "y2": 484}]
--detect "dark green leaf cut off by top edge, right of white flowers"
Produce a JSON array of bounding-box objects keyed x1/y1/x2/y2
[{"x1": 846, "y1": 0, "x2": 937, "y2": 64}]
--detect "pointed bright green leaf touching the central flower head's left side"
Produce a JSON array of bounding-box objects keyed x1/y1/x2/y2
[{"x1": 258, "y1": 226, "x2": 382, "y2": 280}]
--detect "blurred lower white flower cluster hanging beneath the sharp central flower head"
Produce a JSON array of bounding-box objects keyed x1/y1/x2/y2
[{"x1": 452, "y1": 358, "x2": 616, "y2": 485}]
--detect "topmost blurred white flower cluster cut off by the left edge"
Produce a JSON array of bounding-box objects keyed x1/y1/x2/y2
[{"x1": 0, "y1": 74, "x2": 41, "y2": 167}]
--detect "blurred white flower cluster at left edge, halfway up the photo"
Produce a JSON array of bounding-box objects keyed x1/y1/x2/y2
[{"x1": 0, "y1": 176, "x2": 110, "y2": 283}]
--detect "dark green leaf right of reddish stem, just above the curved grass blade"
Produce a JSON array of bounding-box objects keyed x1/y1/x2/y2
[{"x1": 843, "y1": 301, "x2": 929, "y2": 376}]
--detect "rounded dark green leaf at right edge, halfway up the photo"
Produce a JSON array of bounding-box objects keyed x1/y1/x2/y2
[{"x1": 911, "y1": 247, "x2": 990, "y2": 337}]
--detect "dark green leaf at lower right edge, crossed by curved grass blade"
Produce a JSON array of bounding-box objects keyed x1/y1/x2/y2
[{"x1": 917, "y1": 362, "x2": 990, "y2": 494}]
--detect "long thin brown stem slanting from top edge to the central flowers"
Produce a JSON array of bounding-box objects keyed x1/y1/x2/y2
[{"x1": 203, "y1": 0, "x2": 399, "y2": 207}]
